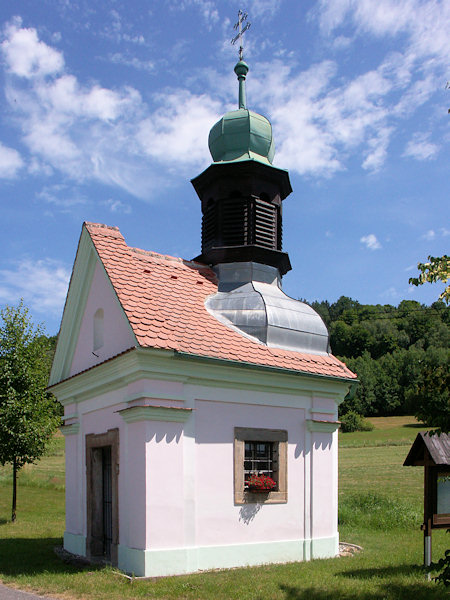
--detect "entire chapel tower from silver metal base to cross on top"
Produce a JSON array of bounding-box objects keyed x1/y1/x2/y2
[{"x1": 192, "y1": 12, "x2": 328, "y2": 355}]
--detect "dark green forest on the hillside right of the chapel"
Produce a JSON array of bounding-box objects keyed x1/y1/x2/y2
[{"x1": 310, "y1": 296, "x2": 450, "y2": 426}]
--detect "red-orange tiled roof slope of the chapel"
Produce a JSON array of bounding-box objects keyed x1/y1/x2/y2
[{"x1": 85, "y1": 223, "x2": 356, "y2": 379}]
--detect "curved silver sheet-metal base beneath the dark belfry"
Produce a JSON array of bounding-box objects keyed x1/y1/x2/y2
[{"x1": 206, "y1": 262, "x2": 329, "y2": 355}]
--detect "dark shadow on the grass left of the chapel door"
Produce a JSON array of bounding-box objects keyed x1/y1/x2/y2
[{"x1": 0, "y1": 538, "x2": 101, "y2": 576}]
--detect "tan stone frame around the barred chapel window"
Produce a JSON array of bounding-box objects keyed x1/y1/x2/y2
[{"x1": 234, "y1": 427, "x2": 288, "y2": 504}]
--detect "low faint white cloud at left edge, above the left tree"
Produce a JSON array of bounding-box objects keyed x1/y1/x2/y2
[{"x1": 0, "y1": 258, "x2": 70, "y2": 315}]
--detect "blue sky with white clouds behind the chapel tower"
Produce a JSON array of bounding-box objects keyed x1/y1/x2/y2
[{"x1": 0, "y1": 0, "x2": 450, "y2": 334}]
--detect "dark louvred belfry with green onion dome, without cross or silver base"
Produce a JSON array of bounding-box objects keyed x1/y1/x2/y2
[{"x1": 192, "y1": 60, "x2": 292, "y2": 275}]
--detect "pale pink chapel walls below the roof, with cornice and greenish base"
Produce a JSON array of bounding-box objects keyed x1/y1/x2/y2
[{"x1": 57, "y1": 354, "x2": 344, "y2": 575}]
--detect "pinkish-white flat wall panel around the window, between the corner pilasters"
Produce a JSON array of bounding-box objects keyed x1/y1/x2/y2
[{"x1": 195, "y1": 398, "x2": 305, "y2": 546}]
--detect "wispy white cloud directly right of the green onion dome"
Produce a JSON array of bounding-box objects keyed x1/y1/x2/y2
[{"x1": 252, "y1": 60, "x2": 394, "y2": 176}]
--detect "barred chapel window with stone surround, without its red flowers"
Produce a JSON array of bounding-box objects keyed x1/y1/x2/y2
[{"x1": 234, "y1": 427, "x2": 287, "y2": 504}]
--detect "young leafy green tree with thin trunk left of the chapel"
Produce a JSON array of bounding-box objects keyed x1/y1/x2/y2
[{"x1": 0, "y1": 301, "x2": 61, "y2": 521}]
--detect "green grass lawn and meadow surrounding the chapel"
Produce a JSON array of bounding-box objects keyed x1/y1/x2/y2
[{"x1": 0, "y1": 417, "x2": 450, "y2": 600}]
